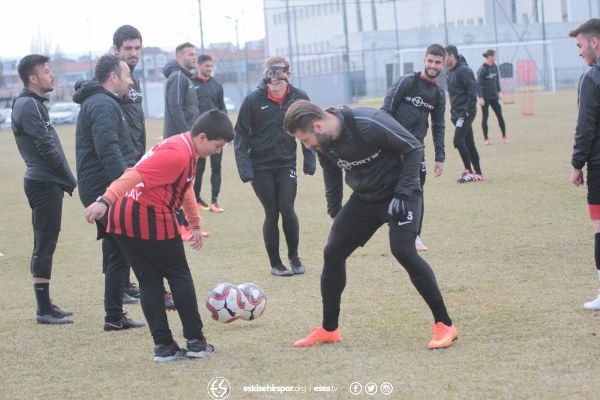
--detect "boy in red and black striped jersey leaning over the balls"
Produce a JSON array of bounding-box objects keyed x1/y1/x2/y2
[{"x1": 85, "y1": 110, "x2": 233, "y2": 361}]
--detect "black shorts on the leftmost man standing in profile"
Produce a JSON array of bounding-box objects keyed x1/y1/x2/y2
[{"x1": 23, "y1": 179, "x2": 64, "y2": 231}]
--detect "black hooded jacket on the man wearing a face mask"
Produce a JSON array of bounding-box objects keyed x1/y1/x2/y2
[{"x1": 234, "y1": 81, "x2": 317, "y2": 182}]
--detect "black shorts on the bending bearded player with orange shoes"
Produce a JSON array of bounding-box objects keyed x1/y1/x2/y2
[{"x1": 331, "y1": 193, "x2": 423, "y2": 246}]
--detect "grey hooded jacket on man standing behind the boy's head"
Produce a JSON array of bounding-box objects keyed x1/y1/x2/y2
[{"x1": 163, "y1": 60, "x2": 199, "y2": 138}]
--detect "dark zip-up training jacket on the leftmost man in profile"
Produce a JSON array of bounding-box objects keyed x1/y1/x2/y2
[{"x1": 11, "y1": 89, "x2": 77, "y2": 195}]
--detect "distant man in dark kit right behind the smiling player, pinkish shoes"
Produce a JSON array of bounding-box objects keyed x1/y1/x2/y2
[{"x1": 446, "y1": 46, "x2": 483, "y2": 183}]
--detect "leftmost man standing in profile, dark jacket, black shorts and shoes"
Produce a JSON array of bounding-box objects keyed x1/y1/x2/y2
[{"x1": 11, "y1": 54, "x2": 77, "y2": 324}]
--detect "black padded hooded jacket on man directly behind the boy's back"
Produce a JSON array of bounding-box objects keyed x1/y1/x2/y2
[{"x1": 73, "y1": 81, "x2": 136, "y2": 207}]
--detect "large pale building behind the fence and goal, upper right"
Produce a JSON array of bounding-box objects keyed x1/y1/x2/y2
[{"x1": 264, "y1": 0, "x2": 599, "y2": 103}]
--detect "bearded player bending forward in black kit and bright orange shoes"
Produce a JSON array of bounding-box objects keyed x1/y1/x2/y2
[{"x1": 284, "y1": 100, "x2": 458, "y2": 349}]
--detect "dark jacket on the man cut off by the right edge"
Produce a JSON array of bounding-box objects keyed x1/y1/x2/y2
[{"x1": 571, "y1": 57, "x2": 600, "y2": 169}]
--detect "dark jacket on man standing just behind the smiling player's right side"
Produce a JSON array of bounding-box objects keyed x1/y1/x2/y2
[{"x1": 446, "y1": 55, "x2": 478, "y2": 119}]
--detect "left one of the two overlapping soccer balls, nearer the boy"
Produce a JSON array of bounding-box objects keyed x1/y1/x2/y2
[{"x1": 206, "y1": 283, "x2": 245, "y2": 324}]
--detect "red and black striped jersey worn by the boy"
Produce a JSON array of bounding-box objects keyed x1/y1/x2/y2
[{"x1": 107, "y1": 132, "x2": 198, "y2": 240}]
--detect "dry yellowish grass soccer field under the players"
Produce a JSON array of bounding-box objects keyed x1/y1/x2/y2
[{"x1": 0, "y1": 91, "x2": 600, "y2": 400}]
